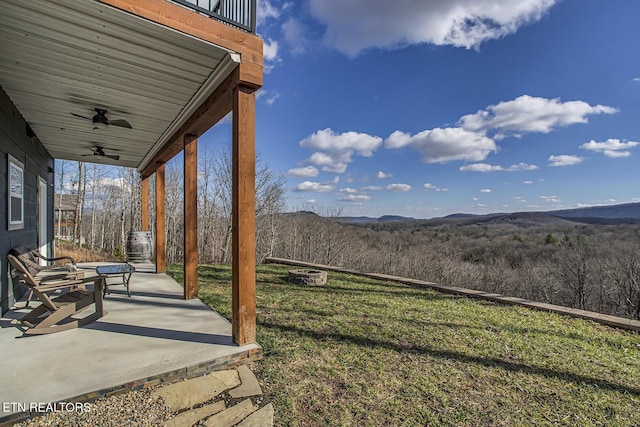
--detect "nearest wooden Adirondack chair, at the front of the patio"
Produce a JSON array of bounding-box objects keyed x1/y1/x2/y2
[{"x1": 8, "y1": 255, "x2": 106, "y2": 335}]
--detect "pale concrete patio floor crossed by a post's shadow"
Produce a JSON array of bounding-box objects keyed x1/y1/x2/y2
[{"x1": 0, "y1": 263, "x2": 262, "y2": 423}]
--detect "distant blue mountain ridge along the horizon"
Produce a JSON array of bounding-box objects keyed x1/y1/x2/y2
[{"x1": 340, "y1": 203, "x2": 640, "y2": 225}]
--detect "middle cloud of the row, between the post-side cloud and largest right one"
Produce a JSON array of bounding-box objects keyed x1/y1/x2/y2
[{"x1": 384, "y1": 128, "x2": 498, "y2": 163}]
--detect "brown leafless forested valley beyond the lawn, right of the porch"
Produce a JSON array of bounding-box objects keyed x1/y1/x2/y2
[{"x1": 274, "y1": 213, "x2": 640, "y2": 319}]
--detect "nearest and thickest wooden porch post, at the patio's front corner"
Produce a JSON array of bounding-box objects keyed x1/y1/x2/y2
[{"x1": 231, "y1": 86, "x2": 256, "y2": 345}]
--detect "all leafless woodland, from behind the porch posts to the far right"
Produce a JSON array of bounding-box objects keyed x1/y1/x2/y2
[{"x1": 61, "y1": 159, "x2": 640, "y2": 319}]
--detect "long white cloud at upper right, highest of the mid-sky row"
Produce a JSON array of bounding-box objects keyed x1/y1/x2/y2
[{"x1": 458, "y1": 95, "x2": 618, "y2": 139}]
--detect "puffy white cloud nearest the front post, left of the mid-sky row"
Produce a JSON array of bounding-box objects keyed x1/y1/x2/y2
[{"x1": 300, "y1": 128, "x2": 382, "y2": 173}]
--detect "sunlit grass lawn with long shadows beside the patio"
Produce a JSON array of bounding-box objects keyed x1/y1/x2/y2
[{"x1": 169, "y1": 265, "x2": 640, "y2": 426}]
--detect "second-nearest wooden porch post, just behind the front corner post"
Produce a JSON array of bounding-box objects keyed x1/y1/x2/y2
[{"x1": 184, "y1": 135, "x2": 198, "y2": 299}]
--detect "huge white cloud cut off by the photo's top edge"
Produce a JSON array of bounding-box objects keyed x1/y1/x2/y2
[{"x1": 310, "y1": 0, "x2": 556, "y2": 56}]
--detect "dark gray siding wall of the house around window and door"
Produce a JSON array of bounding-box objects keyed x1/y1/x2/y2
[{"x1": 0, "y1": 87, "x2": 54, "y2": 314}]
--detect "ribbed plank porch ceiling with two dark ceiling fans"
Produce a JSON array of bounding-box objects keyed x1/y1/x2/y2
[{"x1": 0, "y1": 0, "x2": 248, "y2": 169}]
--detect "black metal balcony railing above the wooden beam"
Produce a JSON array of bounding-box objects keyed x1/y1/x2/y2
[{"x1": 171, "y1": 0, "x2": 256, "y2": 34}]
